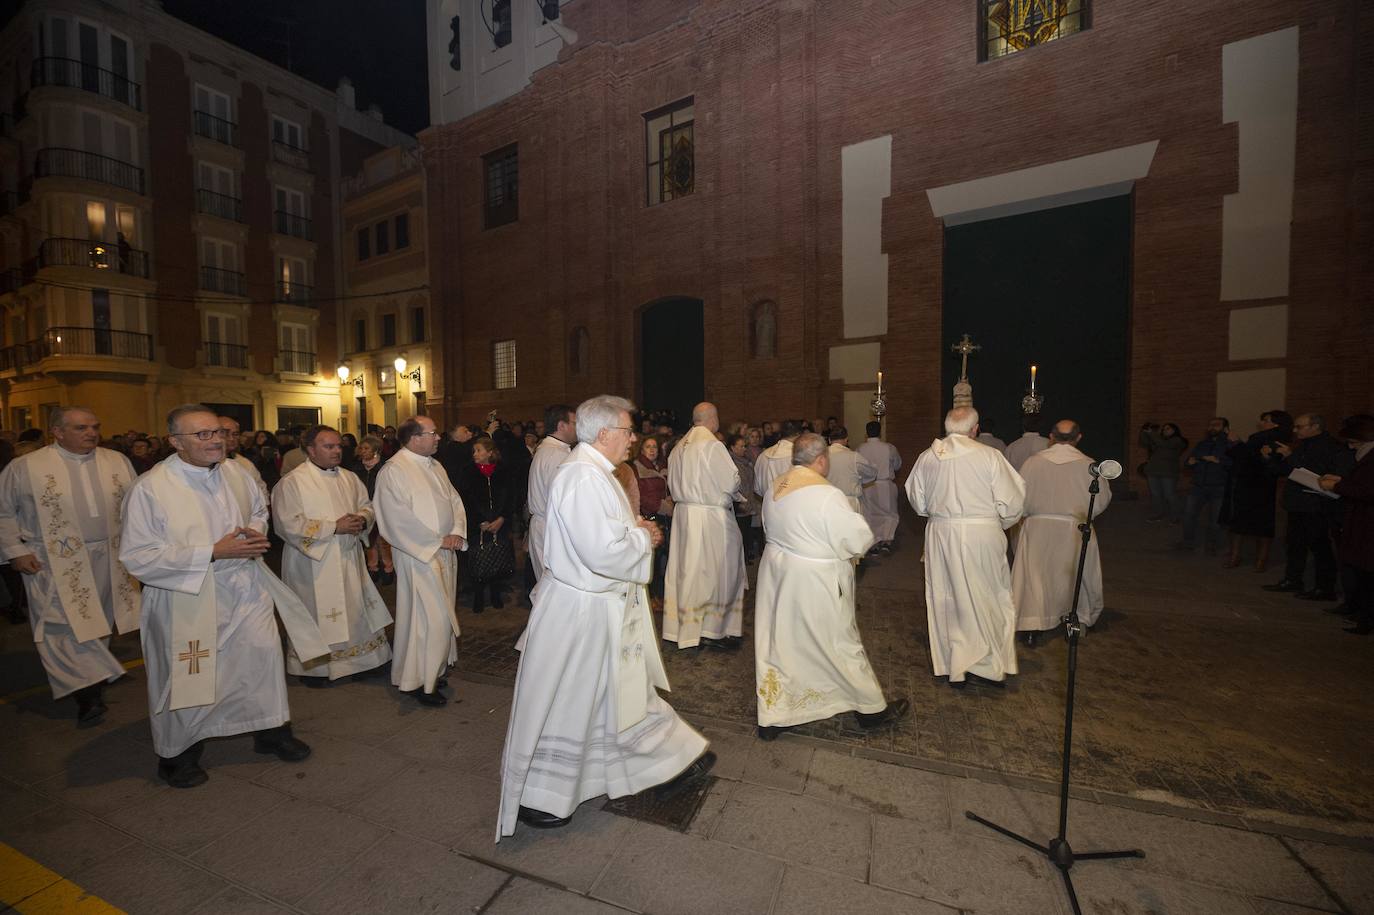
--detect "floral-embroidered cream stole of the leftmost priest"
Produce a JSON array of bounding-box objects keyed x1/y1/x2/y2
[{"x1": 25, "y1": 445, "x2": 139, "y2": 642}]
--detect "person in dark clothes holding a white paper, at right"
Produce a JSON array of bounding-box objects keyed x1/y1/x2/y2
[{"x1": 1264, "y1": 414, "x2": 1353, "y2": 600}]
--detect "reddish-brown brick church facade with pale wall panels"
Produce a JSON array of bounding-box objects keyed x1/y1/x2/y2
[{"x1": 420, "y1": 0, "x2": 1374, "y2": 462}]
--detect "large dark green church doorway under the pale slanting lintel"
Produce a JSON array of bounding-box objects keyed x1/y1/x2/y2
[{"x1": 941, "y1": 195, "x2": 1132, "y2": 463}]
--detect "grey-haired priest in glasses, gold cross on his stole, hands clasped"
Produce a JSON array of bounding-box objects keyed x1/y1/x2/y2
[{"x1": 120, "y1": 404, "x2": 328, "y2": 787}]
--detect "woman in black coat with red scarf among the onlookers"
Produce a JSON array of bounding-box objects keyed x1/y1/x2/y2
[{"x1": 458, "y1": 436, "x2": 519, "y2": 613}]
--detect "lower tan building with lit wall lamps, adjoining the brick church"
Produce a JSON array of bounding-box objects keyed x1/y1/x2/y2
[{"x1": 337, "y1": 147, "x2": 442, "y2": 433}]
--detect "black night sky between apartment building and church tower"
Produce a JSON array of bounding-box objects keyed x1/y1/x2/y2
[{"x1": 170, "y1": 0, "x2": 429, "y2": 133}]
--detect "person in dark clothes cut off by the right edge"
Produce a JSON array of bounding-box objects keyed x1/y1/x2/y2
[{"x1": 1322, "y1": 415, "x2": 1374, "y2": 635}]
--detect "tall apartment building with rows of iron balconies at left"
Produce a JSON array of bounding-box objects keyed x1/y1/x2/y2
[{"x1": 0, "y1": 0, "x2": 414, "y2": 430}]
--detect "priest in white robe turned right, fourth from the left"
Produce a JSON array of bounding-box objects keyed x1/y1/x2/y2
[{"x1": 372, "y1": 416, "x2": 467, "y2": 706}]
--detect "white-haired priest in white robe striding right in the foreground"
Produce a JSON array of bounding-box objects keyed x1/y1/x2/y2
[{"x1": 496, "y1": 396, "x2": 716, "y2": 842}]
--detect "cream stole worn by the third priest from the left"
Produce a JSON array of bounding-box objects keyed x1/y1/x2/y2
[{"x1": 283, "y1": 462, "x2": 392, "y2": 645}]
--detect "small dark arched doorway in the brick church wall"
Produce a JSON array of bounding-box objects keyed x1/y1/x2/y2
[{"x1": 639, "y1": 298, "x2": 706, "y2": 430}]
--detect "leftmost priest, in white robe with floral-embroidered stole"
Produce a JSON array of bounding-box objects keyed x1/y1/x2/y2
[{"x1": 0, "y1": 407, "x2": 139, "y2": 725}]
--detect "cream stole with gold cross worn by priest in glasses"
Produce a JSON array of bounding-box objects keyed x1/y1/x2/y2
[{"x1": 147, "y1": 458, "x2": 330, "y2": 712}]
